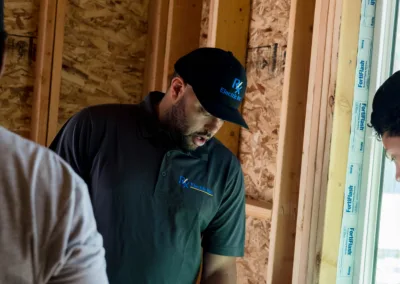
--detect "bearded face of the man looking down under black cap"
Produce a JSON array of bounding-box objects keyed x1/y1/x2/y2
[{"x1": 165, "y1": 85, "x2": 224, "y2": 151}]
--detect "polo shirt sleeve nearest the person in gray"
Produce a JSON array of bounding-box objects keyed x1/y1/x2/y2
[{"x1": 49, "y1": 108, "x2": 92, "y2": 182}]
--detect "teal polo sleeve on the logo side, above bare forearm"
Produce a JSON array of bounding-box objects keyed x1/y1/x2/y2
[{"x1": 203, "y1": 165, "x2": 246, "y2": 257}]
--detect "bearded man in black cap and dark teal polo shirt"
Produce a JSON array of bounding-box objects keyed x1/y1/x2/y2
[{"x1": 50, "y1": 48, "x2": 247, "y2": 284}]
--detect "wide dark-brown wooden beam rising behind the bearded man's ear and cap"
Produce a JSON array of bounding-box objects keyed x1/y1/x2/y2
[{"x1": 163, "y1": 0, "x2": 203, "y2": 91}]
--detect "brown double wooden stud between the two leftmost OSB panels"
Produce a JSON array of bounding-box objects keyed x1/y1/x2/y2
[{"x1": 31, "y1": 0, "x2": 66, "y2": 145}]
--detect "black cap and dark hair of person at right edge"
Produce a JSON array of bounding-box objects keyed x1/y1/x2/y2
[{"x1": 369, "y1": 72, "x2": 400, "y2": 139}]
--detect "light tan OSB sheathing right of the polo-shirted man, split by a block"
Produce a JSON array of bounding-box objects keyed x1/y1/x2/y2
[{"x1": 200, "y1": 0, "x2": 290, "y2": 284}]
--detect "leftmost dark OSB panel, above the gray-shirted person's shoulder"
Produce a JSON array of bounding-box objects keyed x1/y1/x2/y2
[{"x1": 0, "y1": 0, "x2": 39, "y2": 138}]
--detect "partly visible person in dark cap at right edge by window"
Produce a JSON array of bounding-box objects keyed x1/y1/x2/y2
[{"x1": 371, "y1": 71, "x2": 400, "y2": 182}]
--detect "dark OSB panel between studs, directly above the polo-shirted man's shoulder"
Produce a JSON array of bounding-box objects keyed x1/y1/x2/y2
[{"x1": 58, "y1": 0, "x2": 149, "y2": 128}]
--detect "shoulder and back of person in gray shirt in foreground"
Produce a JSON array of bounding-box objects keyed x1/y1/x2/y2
[{"x1": 0, "y1": 127, "x2": 108, "y2": 284}]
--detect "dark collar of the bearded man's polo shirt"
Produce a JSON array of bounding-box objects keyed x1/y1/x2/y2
[{"x1": 139, "y1": 92, "x2": 209, "y2": 161}]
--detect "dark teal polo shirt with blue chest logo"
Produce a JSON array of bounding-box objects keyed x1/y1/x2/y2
[{"x1": 50, "y1": 92, "x2": 245, "y2": 284}]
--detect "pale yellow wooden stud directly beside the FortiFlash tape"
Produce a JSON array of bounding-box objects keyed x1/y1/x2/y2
[{"x1": 318, "y1": 1, "x2": 361, "y2": 284}]
